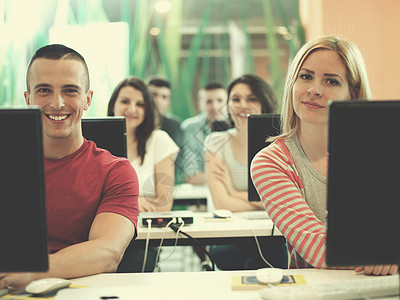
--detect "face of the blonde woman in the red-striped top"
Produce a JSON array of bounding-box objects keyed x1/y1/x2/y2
[{"x1": 293, "y1": 50, "x2": 351, "y2": 127}]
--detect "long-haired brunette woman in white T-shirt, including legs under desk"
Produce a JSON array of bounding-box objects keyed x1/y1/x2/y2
[{"x1": 107, "y1": 77, "x2": 179, "y2": 272}]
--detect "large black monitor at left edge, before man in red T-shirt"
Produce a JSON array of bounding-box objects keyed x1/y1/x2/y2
[{"x1": 0, "y1": 107, "x2": 48, "y2": 273}]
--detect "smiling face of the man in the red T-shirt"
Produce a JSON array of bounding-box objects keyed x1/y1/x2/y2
[{"x1": 24, "y1": 58, "x2": 93, "y2": 143}]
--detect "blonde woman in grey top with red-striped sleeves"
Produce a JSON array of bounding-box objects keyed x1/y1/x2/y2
[{"x1": 251, "y1": 37, "x2": 398, "y2": 275}]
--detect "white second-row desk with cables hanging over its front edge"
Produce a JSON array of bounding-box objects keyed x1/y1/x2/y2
[{"x1": 134, "y1": 212, "x2": 282, "y2": 245}]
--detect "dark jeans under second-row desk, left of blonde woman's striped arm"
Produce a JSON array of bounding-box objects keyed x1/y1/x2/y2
[{"x1": 210, "y1": 237, "x2": 288, "y2": 270}]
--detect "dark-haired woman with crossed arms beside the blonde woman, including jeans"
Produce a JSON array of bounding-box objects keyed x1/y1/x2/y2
[{"x1": 204, "y1": 74, "x2": 287, "y2": 270}]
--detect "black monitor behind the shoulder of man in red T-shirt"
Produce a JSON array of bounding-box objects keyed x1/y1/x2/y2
[{"x1": 82, "y1": 117, "x2": 127, "y2": 157}]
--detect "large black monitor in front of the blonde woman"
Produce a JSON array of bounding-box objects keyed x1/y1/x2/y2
[{"x1": 326, "y1": 101, "x2": 400, "y2": 266}]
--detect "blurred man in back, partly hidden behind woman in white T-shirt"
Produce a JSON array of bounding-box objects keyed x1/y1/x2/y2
[{"x1": 147, "y1": 77, "x2": 182, "y2": 147}]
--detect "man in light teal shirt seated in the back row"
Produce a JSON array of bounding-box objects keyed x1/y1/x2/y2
[{"x1": 178, "y1": 82, "x2": 228, "y2": 184}]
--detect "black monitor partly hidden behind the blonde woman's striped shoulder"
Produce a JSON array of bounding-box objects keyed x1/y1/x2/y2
[{"x1": 247, "y1": 114, "x2": 281, "y2": 201}]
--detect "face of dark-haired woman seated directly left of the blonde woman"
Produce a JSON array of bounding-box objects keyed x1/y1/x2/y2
[{"x1": 228, "y1": 83, "x2": 262, "y2": 129}]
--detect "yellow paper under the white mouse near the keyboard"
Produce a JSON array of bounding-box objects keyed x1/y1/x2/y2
[{"x1": 231, "y1": 275, "x2": 306, "y2": 290}]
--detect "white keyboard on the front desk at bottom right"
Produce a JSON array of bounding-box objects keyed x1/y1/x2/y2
[{"x1": 260, "y1": 274, "x2": 400, "y2": 300}]
